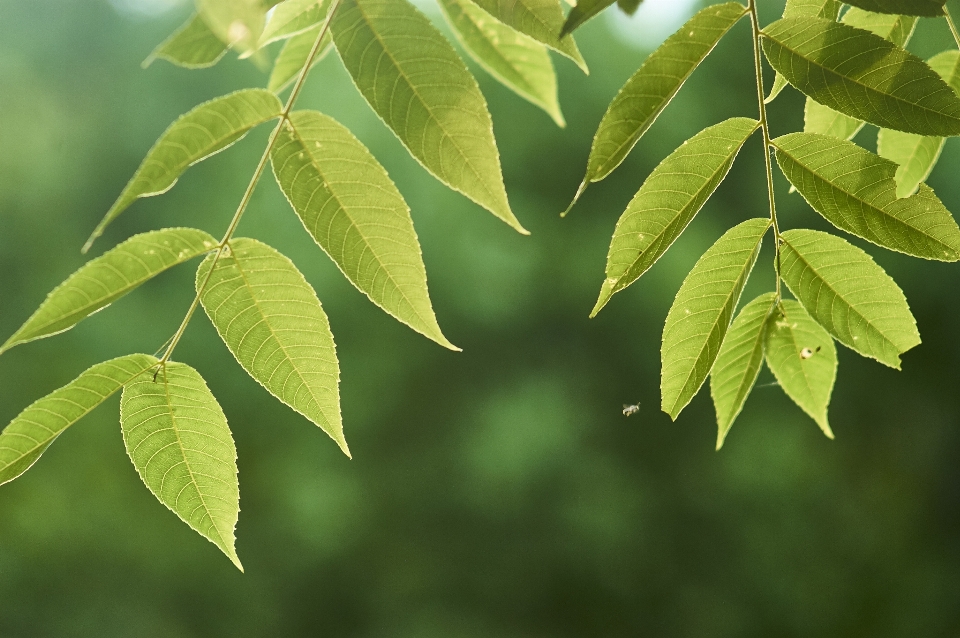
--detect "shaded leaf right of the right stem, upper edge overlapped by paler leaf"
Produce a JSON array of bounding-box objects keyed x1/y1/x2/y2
[{"x1": 774, "y1": 133, "x2": 960, "y2": 261}]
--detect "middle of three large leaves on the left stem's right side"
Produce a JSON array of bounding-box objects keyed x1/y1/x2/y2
[{"x1": 271, "y1": 111, "x2": 457, "y2": 350}]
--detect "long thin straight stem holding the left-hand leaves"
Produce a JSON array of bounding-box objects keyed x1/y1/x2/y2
[{"x1": 153, "y1": 0, "x2": 340, "y2": 380}]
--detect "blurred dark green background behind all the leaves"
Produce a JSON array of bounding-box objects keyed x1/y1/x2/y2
[{"x1": 0, "y1": 0, "x2": 960, "y2": 638}]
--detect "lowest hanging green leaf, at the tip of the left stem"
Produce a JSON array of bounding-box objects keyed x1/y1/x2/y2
[{"x1": 120, "y1": 361, "x2": 243, "y2": 571}]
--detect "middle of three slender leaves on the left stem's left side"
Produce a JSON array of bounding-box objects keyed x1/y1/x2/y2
[{"x1": 0, "y1": 228, "x2": 217, "y2": 354}]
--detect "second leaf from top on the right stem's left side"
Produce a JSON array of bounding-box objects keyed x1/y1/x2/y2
[{"x1": 590, "y1": 117, "x2": 760, "y2": 317}]
